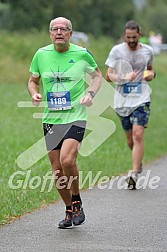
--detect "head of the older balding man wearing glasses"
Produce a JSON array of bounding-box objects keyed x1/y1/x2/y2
[{"x1": 50, "y1": 18, "x2": 72, "y2": 45}]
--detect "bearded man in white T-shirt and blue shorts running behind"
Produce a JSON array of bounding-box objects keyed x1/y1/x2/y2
[{"x1": 106, "y1": 20, "x2": 156, "y2": 189}]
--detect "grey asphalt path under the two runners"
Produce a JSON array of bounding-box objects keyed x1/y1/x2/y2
[{"x1": 0, "y1": 157, "x2": 167, "y2": 252}]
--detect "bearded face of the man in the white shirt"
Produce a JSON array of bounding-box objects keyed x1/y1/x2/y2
[{"x1": 124, "y1": 29, "x2": 140, "y2": 50}]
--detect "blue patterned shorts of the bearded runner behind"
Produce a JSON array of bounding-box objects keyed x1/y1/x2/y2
[{"x1": 118, "y1": 102, "x2": 150, "y2": 131}]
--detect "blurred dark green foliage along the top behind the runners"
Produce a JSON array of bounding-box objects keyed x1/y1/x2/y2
[{"x1": 0, "y1": 0, "x2": 167, "y2": 40}]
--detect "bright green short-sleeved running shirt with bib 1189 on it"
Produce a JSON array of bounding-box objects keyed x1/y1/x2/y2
[{"x1": 29, "y1": 43, "x2": 97, "y2": 124}]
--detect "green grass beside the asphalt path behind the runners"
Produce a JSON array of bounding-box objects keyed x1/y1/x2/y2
[{"x1": 0, "y1": 34, "x2": 167, "y2": 224}]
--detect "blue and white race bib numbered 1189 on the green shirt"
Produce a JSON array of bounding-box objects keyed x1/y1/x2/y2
[{"x1": 47, "y1": 91, "x2": 71, "y2": 110}]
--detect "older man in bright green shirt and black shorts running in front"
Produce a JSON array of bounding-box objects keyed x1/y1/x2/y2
[{"x1": 28, "y1": 17, "x2": 102, "y2": 228}]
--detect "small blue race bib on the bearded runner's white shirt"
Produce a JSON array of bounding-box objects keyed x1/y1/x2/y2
[{"x1": 123, "y1": 82, "x2": 142, "y2": 95}]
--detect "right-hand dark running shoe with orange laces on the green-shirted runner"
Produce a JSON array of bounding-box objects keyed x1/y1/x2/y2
[{"x1": 72, "y1": 201, "x2": 85, "y2": 226}]
